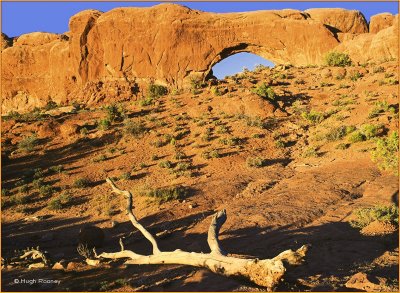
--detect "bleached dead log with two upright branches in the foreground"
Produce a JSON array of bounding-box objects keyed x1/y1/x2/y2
[{"x1": 94, "y1": 178, "x2": 308, "y2": 289}]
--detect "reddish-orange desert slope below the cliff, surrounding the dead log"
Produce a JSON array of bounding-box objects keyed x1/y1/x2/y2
[{"x1": 1, "y1": 61, "x2": 399, "y2": 291}]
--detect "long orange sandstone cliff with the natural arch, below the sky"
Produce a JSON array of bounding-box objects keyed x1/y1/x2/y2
[{"x1": 1, "y1": 4, "x2": 398, "y2": 114}]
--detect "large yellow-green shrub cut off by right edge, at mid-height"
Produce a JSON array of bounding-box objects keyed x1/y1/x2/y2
[{"x1": 371, "y1": 131, "x2": 399, "y2": 175}]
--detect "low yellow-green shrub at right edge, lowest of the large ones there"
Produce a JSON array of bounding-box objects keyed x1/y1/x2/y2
[{"x1": 350, "y1": 204, "x2": 399, "y2": 229}]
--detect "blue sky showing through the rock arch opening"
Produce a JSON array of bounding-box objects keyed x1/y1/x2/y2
[{"x1": 208, "y1": 52, "x2": 275, "y2": 79}]
